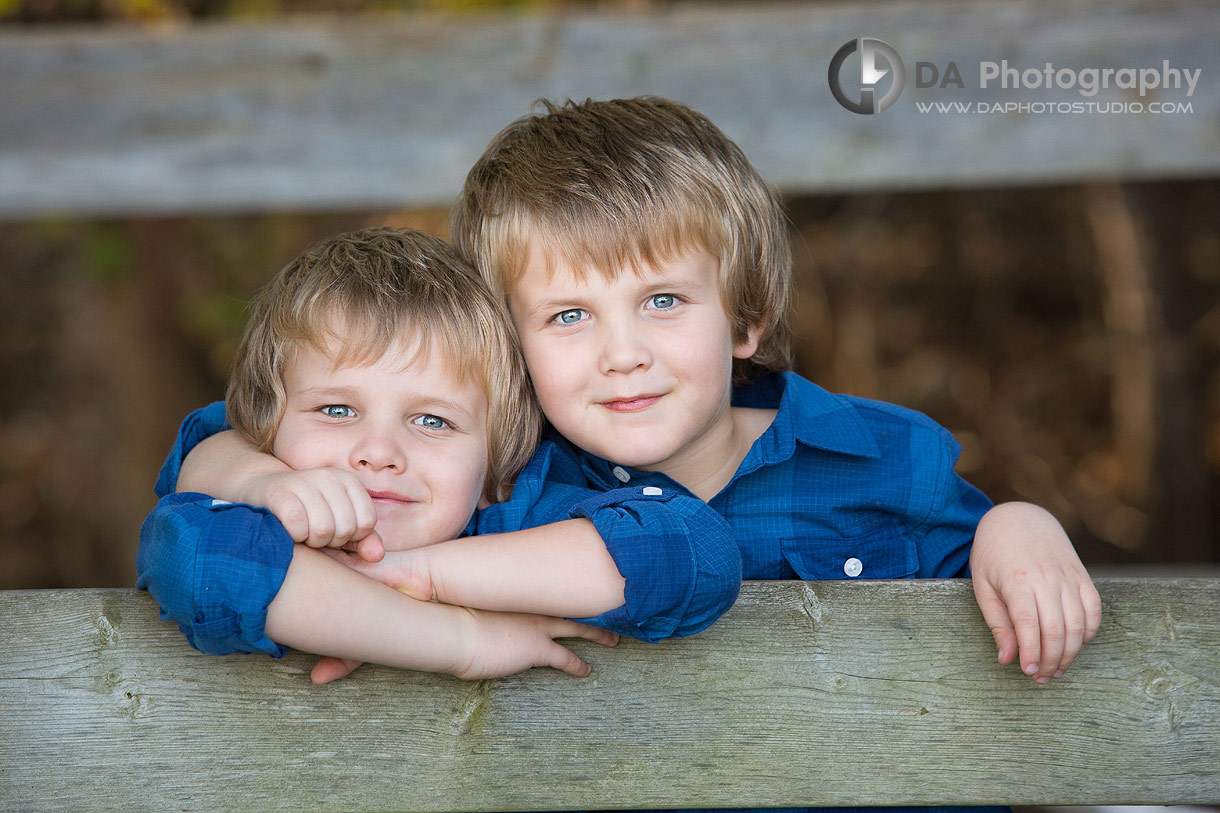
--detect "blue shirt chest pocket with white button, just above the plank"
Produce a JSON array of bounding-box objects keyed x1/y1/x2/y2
[{"x1": 780, "y1": 530, "x2": 919, "y2": 581}]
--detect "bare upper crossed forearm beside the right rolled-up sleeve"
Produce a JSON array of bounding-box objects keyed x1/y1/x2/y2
[{"x1": 419, "y1": 519, "x2": 626, "y2": 618}]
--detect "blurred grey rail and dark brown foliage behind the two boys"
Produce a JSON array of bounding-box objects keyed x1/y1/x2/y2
[{"x1": 0, "y1": 0, "x2": 1220, "y2": 588}]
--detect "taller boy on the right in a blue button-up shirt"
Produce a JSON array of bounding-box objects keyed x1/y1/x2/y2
[{"x1": 353, "y1": 98, "x2": 1100, "y2": 682}]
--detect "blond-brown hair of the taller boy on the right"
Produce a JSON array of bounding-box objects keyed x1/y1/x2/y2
[{"x1": 450, "y1": 96, "x2": 792, "y2": 381}]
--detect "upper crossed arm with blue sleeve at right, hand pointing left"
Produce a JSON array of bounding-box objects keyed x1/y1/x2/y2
[{"x1": 332, "y1": 476, "x2": 742, "y2": 641}]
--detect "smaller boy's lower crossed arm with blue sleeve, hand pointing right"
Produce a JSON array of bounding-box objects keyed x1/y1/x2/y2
[{"x1": 137, "y1": 494, "x2": 615, "y2": 678}]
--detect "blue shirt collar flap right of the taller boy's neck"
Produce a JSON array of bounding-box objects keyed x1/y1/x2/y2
[{"x1": 733, "y1": 371, "x2": 881, "y2": 461}]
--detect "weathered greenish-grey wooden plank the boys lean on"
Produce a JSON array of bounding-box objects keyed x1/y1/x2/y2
[{"x1": 0, "y1": 579, "x2": 1220, "y2": 811}]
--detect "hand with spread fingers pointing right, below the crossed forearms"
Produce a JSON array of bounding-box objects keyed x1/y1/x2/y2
[{"x1": 453, "y1": 609, "x2": 619, "y2": 680}]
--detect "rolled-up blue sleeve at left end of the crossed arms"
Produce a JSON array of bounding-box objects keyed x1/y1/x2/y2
[{"x1": 135, "y1": 493, "x2": 293, "y2": 658}]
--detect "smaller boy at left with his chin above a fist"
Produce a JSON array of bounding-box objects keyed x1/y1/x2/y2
[{"x1": 138, "y1": 228, "x2": 678, "y2": 678}]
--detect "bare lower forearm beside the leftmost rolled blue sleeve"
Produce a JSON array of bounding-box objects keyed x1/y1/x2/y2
[{"x1": 266, "y1": 546, "x2": 472, "y2": 674}]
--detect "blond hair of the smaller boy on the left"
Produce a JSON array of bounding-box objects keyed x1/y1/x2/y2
[{"x1": 224, "y1": 228, "x2": 542, "y2": 502}]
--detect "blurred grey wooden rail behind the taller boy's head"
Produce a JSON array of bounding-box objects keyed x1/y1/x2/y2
[{"x1": 0, "y1": 0, "x2": 1220, "y2": 219}]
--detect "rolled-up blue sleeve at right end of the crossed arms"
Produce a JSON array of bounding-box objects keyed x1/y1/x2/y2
[{"x1": 571, "y1": 486, "x2": 742, "y2": 642}]
